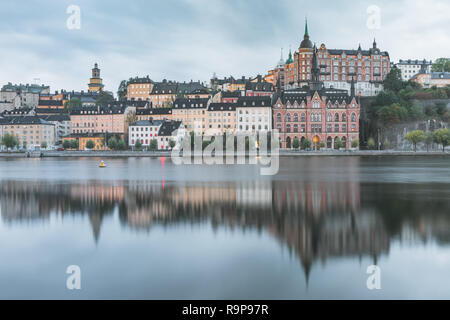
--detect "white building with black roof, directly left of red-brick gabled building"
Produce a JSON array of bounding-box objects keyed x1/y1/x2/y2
[{"x1": 236, "y1": 97, "x2": 272, "y2": 134}]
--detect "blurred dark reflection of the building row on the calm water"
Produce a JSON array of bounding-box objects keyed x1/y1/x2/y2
[{"x1": 0, "y1": 179, "x2": 450, "y2": 276}]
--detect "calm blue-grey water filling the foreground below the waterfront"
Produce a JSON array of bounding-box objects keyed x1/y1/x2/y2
[{"x1": 0, "y1": 157, "x2": 450, "y2": 299}]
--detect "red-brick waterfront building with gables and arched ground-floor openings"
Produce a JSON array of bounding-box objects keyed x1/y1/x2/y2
[{"x1": 273, "y1": 83, "x2": 360, "y2": 149}]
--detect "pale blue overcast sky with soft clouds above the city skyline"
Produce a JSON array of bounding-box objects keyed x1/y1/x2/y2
[{"x1": 0, "y1": 0, "x2": 450, "y2": 93}]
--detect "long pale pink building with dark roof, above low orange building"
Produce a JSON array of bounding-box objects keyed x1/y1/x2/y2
[{"x1": 70, "y1": 104, "x2": 130, "y2": 134}]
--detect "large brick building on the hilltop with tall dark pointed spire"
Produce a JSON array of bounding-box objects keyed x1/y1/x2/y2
[{"x1": 272, "y1": 19, "x2": 390, "y2": 96}]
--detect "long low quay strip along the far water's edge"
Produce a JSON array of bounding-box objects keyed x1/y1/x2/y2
[{"x1": 0, "y1": 150, "x2": 450, "y2": 158}]
